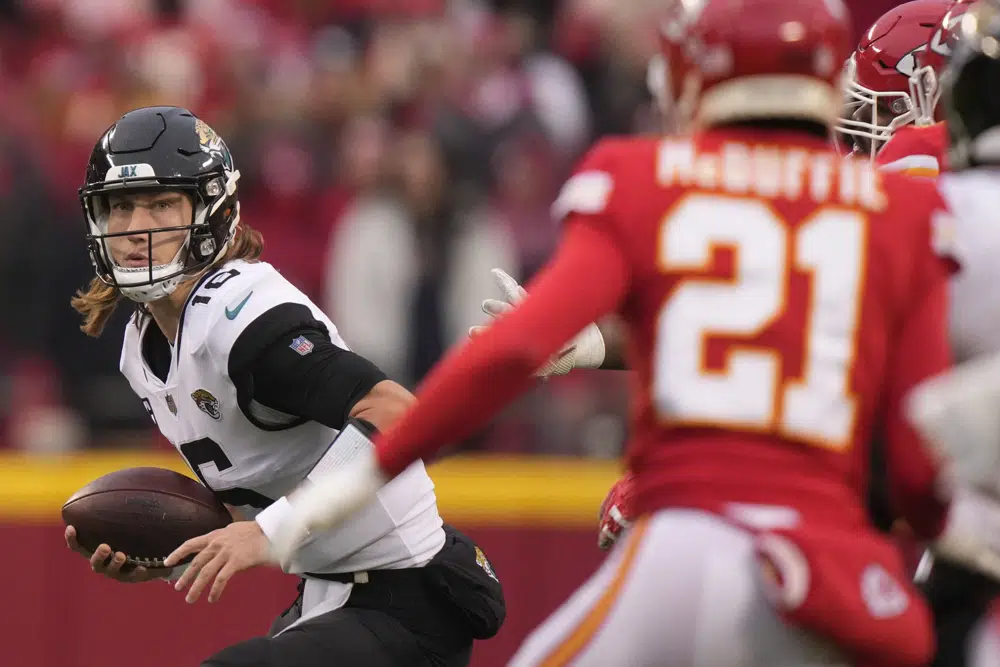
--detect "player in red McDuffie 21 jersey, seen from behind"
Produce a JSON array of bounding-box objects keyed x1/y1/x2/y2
[{"x1": 275, "y1": 0, "x2": 996, "y2": 667}]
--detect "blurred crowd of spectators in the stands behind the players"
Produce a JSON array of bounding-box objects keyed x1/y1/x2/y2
[{"x1": 0, "y1": 0, "x2": 908, "y2": 456}]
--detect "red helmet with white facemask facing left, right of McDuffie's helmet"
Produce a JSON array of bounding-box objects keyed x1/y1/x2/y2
[{"x1": 837, "y1": 0, "x2": 952, "y2": 154}]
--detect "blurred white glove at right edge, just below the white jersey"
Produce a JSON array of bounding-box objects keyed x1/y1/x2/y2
[{"x1": 906, "y1": 355, "x2": 1000, "y2": 497}]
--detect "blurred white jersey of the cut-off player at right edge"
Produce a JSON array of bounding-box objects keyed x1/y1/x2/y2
[{"x1": 938, "y1": 170, "x2": 1000, "y2": 362}]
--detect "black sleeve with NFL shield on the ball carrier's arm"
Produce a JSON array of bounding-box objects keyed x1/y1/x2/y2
[{"x1": 229, "y1": 303, "x2": 386, "y2": 430}]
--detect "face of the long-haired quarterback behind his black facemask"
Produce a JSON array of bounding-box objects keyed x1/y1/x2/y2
[{"x1": 107, "y1": 190, "x2": 193, "y2": 267}]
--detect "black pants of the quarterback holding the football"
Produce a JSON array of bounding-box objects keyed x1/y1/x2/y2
[{"x1": 202, "y1": 525, "x2": 505, "y2": 667}]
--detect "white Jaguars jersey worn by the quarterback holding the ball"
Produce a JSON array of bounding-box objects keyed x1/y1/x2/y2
[{"x1": 121, "y1": 261, "x2": 445, "y2": 573}]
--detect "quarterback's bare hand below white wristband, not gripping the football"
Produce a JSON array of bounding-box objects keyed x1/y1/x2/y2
[{"x1": 163, "y1": 521, "x2": 269, "y2": 603}]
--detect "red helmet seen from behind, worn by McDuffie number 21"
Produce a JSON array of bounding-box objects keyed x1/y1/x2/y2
[{"x1": 654, "y1": 0, "x2": 850, "y2": 127}]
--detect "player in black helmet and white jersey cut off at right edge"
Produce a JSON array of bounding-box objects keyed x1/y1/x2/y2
[{"x1": 916, "y1": 2, "x2": 1000, "y2": 667}]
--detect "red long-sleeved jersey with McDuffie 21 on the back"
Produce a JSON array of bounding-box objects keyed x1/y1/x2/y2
[{"x1": 376, "y1": 130, "x2": 950, "y2": 535}]
